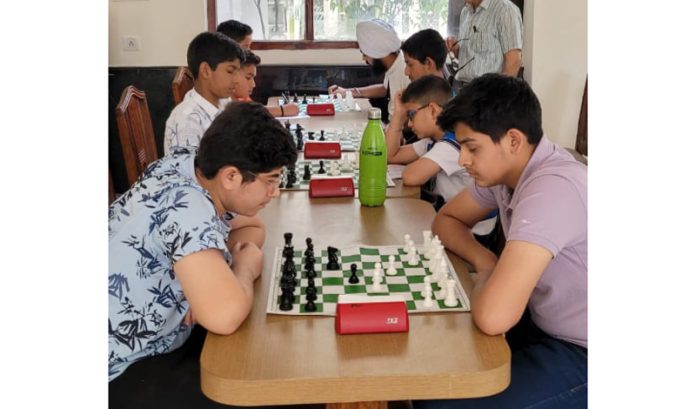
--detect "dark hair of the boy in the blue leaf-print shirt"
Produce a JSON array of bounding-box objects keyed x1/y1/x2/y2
[{"x1": 195, "y1": 101, "x2": 297, "y2": 182}]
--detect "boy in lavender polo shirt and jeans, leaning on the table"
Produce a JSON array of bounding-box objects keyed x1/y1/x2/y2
[{"x1": 414, "y1": 74, "x2": 587, "y2": 409}]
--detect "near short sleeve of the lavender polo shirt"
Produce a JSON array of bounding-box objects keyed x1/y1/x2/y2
[{"x1": 507, "y1": 175, "x2": 587, "y2": 257}]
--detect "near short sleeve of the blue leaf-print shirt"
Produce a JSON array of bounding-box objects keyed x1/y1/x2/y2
[{"x1": 156, "y1": 188, "x2": 229, "y2": 263}]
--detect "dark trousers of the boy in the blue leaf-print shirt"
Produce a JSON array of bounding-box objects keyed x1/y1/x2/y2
[{"x1": 109, "y1": 325, "x2": 323, "y2": 409}]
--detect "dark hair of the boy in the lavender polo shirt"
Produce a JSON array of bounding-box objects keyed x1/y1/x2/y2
[{"x1": 437, "y1": 73, "x2": 544, "y2": 145}]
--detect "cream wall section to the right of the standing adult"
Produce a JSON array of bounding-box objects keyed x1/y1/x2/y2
[{"x1": 522, "y1": 0, "x2": 587, "y2": 147}]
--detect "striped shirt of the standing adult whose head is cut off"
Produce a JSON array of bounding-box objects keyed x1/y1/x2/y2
[{"x1": 456, "y1": 0, "x2": 522, "y2": 82}]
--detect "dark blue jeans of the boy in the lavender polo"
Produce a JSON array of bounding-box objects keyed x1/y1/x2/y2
[{"x1": 413, "y1": 314, "x2": 587, "y2": 409}]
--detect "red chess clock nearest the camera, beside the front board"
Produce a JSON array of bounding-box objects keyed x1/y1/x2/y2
[{"x1": 336, "y1": 294, "x2": 408, "y2": 334}]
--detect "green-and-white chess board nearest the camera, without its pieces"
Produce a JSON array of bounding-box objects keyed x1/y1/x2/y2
[{"x1": 266, "y1": 245, "x2": 470, "y2": 316}]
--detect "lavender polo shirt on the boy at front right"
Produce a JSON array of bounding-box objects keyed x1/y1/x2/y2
[{"x1": 470, "y1": 136, "x2": 587, "y2": 347}]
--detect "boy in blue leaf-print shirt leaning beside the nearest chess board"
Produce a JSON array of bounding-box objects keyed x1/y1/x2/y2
[{"x1": 108, "y1": 102, "x2": 297, "y2": 408}]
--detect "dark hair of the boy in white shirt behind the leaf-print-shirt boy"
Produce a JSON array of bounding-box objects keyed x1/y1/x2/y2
[{"x1": 186, "y1": 31, "x2": 244, "y2": 79}]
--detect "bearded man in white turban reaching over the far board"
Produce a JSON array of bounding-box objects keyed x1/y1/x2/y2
[{"x1": 328, "y1": 18, "x2": 410, "y2": 121}]
